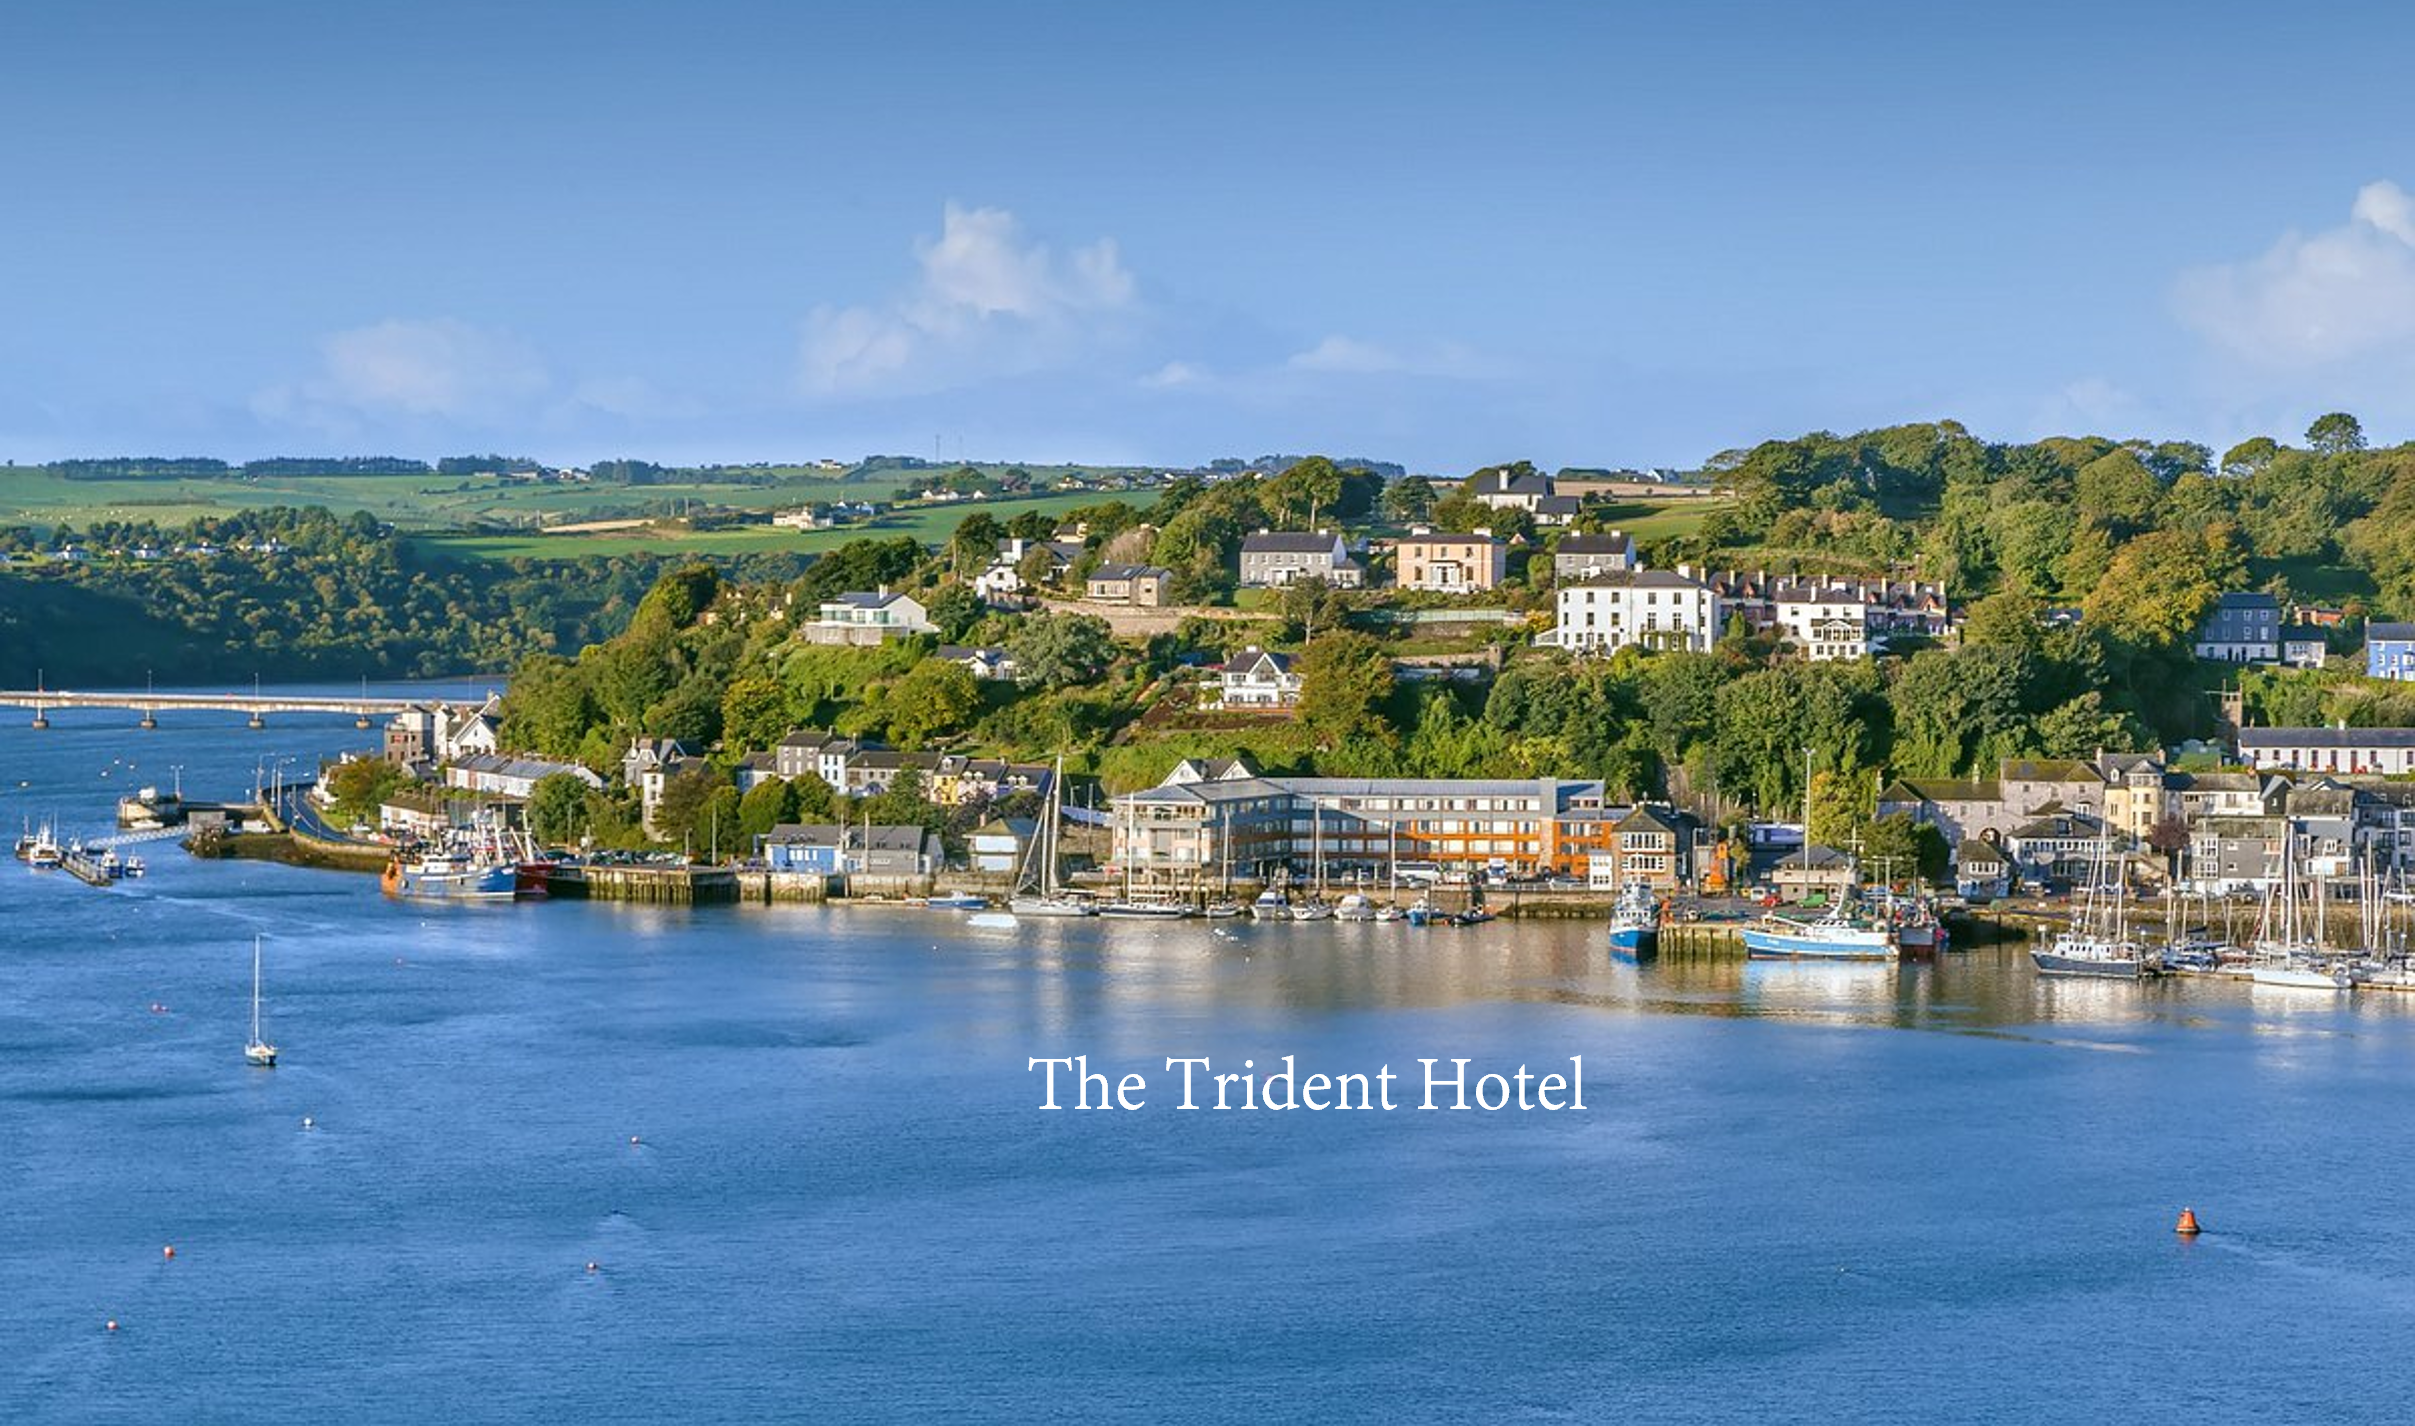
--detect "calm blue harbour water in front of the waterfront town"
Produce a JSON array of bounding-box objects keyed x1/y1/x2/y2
[{"x1": 0, "y1": 715, "x2": 2415, "y2": 1421}]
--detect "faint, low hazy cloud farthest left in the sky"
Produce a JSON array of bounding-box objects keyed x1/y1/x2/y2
[{"x1": 251, "y1": 317, "x2": 553, "y2": 428}]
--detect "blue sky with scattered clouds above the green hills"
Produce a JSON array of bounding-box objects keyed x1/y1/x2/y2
[{"x1": 0, "y1": 0, "x2": 2415, "y2": 471}]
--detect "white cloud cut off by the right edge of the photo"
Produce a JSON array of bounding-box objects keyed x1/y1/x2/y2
[{"x1": 2174, "y1": 181, "x2": 2415, "y2": 367}]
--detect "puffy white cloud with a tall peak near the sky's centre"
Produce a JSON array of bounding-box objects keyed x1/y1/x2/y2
[{"x1": 799, "y1": 203, "x2": 1137, "y2": 396}]
